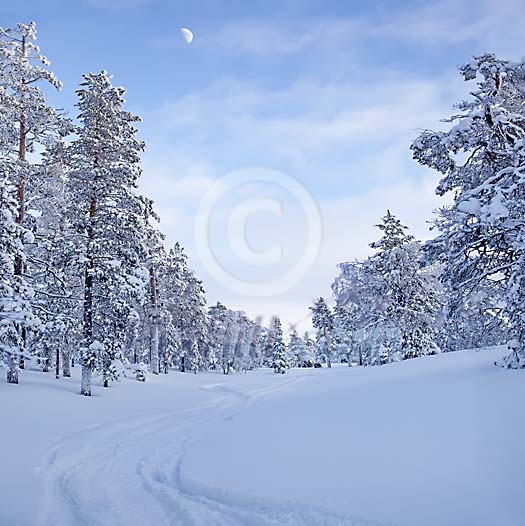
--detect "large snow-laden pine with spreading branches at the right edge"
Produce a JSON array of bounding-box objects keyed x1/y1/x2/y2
[{"x1": 411, "y1": 54, "x2": 525, "y2": 367}]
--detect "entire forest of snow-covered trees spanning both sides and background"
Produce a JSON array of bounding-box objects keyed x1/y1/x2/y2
[{"x1": 0, "y1": 23, "x2": 525, "y2": 402}]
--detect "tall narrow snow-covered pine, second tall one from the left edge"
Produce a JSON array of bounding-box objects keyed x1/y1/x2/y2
[{"x1": 68, "y1": 71, "x2": 147, "y2": 396}]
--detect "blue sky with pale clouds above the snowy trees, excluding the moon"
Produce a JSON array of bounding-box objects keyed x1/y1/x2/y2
[{"x1": 0, "y1": 0, "x2": 525, "y2": 329}]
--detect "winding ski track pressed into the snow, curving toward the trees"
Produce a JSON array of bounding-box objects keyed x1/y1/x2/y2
[{"x1": 35, "y1": 377, "x2": 388, "y2": 526}]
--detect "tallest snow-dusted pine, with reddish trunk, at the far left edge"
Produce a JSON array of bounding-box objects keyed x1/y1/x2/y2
[{"x1": 0, "y1": 22, "x2": 63, "y2": 383}]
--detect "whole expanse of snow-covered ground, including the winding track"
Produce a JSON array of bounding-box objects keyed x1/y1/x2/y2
[{"x1": 0, "y1": 349, "x2": 525, "y2": 526}]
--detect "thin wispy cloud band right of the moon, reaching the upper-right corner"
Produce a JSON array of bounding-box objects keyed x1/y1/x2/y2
[{"x1": 206, "y1": 0, "x2": 525, "y2": 59}]
